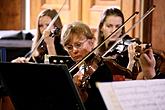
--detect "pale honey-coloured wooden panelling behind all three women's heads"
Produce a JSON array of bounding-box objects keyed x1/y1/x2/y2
[{"x1": 31, "y1": 0, "x2": 141, "y2": 40}]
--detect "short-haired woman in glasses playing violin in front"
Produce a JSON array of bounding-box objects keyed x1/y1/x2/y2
[{"x1": 61, "y1": 21, "x2": 112, "y2": 110}]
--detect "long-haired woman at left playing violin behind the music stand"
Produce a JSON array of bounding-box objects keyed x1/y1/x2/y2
[{"x1": 11, "y1": 9, "x2": 68, "y2": 63}]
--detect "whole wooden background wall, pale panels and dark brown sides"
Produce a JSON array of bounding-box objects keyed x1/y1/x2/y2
[{"x1": 0, "y1": 0, "x2": 165, "y2": 50}]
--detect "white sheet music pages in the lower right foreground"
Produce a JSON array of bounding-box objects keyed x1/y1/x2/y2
[{"x1": 96, "y1": 79, "x2": 165, "y2": 110}]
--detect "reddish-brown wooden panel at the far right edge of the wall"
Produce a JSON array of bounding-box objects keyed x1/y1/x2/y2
[{"x1": 151, "y1": 0, "x2": 165, "y2": 51}]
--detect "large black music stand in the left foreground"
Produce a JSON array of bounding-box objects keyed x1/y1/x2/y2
[{"x1": 0, "y1": 63, "x2": 85, "y2": 110}]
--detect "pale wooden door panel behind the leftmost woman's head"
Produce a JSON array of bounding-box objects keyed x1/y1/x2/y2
[{"x1": 31, "y1": 0, "x2": 82, "y2": 28}]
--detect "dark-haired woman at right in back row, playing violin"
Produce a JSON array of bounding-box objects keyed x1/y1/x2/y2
[{"x1": 97, "y1": 7, "x2": 140, "y2": 71}]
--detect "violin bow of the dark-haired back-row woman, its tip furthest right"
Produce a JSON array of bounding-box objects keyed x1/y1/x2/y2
[{"x1": 102, "y1": 6, "x2": 155, "y2": 57}]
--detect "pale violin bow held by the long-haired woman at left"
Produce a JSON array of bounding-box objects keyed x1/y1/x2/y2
[{"x1": 24, "y1": 0, "x2": 66, "y2": 60}]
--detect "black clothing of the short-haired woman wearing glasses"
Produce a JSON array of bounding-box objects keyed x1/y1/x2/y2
[{"x1": 84, "y1": 57, "x2": 113, "y2": 110}]
